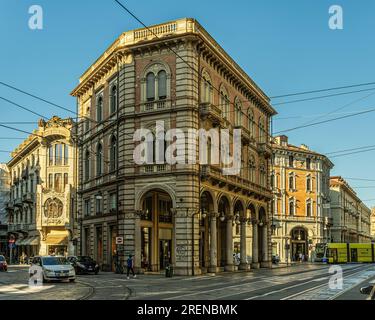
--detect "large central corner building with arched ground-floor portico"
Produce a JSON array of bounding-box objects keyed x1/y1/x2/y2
[{"x1": 72, "y1": 19, "x2": 276, "y2": 275}]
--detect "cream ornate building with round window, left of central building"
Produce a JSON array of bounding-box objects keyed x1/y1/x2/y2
[{"x1": 8, "y1": 117, "x2": 77, "y2": 257}]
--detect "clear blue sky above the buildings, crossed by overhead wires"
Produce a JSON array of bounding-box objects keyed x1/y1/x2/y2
[{"x1": 0, "y1": 0, "x2": 375, "y2": 205}]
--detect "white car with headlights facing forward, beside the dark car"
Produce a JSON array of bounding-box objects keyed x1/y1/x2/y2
[{"x1": 32, "y1": 256, "x2": 76, "y2": 282}]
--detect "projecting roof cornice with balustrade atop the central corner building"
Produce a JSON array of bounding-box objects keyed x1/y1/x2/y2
[{"x1": 71, "y1": 18, "x2": 277, "y2": 115}]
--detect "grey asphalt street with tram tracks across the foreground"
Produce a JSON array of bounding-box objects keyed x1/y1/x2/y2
[{"x1": 0, "y1": 264, "x2": 375, "y2": 300}]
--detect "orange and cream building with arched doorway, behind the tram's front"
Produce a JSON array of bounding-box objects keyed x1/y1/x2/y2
[{"x1": 271, "y1": 136, "x2": 333, "y2": 262}]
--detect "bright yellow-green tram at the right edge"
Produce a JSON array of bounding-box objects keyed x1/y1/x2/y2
[{"x1": 319, "y1": 243, "x2": 375, "y2": 263}]
